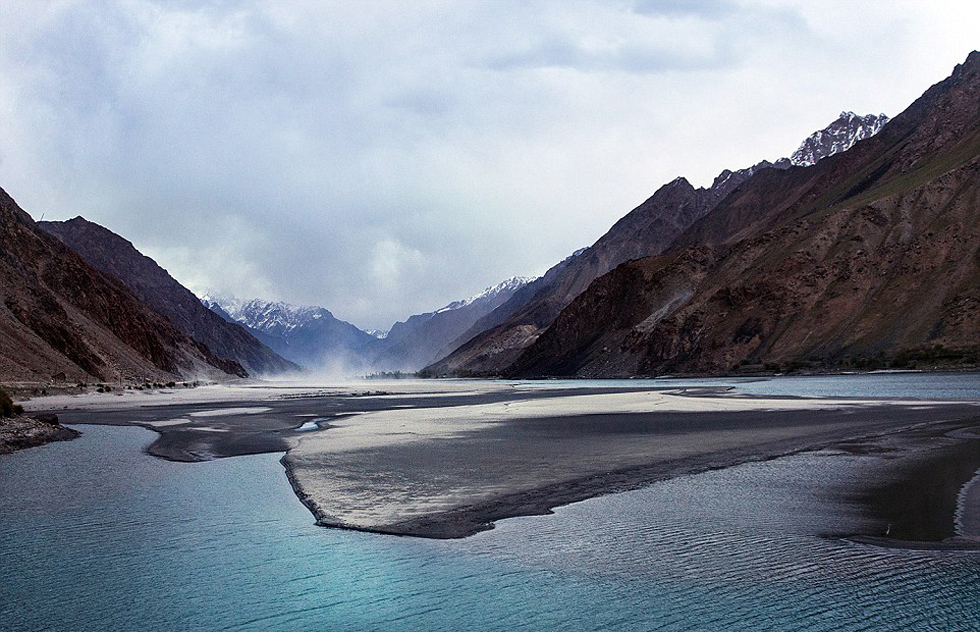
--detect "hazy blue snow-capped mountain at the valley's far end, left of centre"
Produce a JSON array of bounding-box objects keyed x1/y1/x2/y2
[{"x1": 201, "y1": 294, "x2": 376, "y2": 368}]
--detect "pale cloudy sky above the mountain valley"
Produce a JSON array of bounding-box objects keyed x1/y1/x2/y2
[{"x1": 0, "y1": 0, "x2": 980, "y2": 329}]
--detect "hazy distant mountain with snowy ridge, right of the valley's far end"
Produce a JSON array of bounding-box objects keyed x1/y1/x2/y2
[{"x1": 365, "y1": 277, "x2": 532, "y2": 371}]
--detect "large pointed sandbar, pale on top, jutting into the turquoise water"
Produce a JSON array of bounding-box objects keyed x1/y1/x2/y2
[{"x1": 283, "y1": 392, "x2": 980, "y2": 538}]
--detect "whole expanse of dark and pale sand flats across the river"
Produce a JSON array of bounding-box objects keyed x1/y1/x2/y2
[{"x1": 26, "y1": 381, "x2": 980, "y2": 544}]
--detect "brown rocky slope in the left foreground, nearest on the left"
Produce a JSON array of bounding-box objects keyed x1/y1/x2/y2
[{"x1": 0, "y1": 189, "x2": 247, "y2": 383}]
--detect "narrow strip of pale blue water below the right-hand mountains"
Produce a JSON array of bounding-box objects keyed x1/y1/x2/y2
[{"x1": 513, "y1": 372, "x2": 980, "y2": 400}]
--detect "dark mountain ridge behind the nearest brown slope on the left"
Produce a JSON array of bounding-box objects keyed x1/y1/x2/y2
[{"x1": 38, "y1": 217, "x2": 299, "y2": 375}]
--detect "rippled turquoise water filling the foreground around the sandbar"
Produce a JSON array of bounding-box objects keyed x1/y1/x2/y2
[{"x1": 0, "y1": 426, "x2": 980, "y2": 632}]
